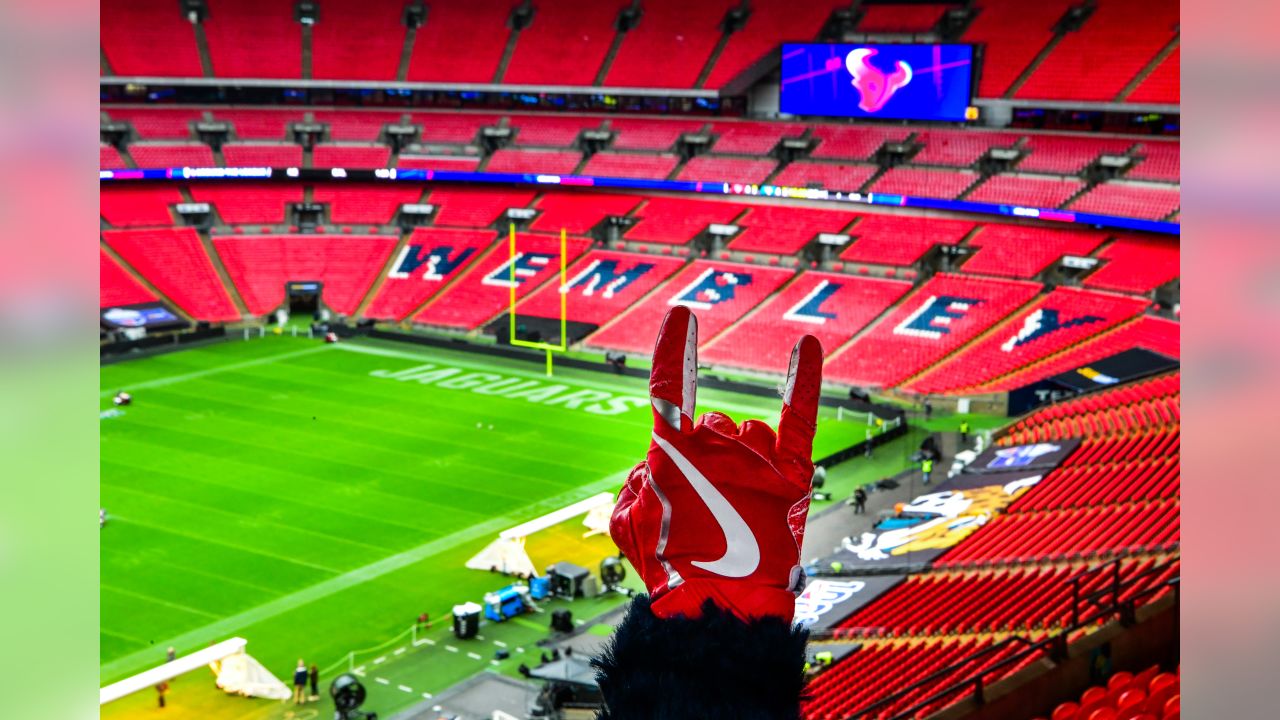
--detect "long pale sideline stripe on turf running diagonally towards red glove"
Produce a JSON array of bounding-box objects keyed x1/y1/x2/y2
[{"x1": 99, "y1": 473, "x2": 626, "y2": 680}]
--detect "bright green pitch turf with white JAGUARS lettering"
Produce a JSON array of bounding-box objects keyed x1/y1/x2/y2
[{"x1": 100, "y1": 336, "x2": 890, "y2": 717}]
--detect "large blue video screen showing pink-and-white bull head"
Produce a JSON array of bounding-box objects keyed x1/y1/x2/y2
[{"x1": 781, "y1": 44, "x2": 973, "y2": 122}]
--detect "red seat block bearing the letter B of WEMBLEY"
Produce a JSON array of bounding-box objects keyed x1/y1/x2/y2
[{"x1": 586, "y1": 260, "x2": 794, "y2": 357}]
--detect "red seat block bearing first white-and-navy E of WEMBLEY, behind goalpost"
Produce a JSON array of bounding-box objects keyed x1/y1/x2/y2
[{"x1": 413, "y1": 233, "x2": 590, "y2": 331}]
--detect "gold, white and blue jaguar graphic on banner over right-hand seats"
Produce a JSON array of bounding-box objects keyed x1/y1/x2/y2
[{"x1": 828, "y1": 471, "x2": 1043, "y2": 571}]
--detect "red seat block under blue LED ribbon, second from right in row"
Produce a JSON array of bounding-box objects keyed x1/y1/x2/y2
[{"x1": 961, "y1": 225, "x2": 1106, "y2": 278}]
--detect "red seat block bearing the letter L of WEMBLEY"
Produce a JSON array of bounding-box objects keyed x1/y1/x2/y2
[{"x1": 699, "y1": 273, "x2": 911, "y2": 374}]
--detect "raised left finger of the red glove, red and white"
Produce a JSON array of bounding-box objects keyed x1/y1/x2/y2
[{"x1": 649, "y1": 305, "x2": 698, "y2": 430}]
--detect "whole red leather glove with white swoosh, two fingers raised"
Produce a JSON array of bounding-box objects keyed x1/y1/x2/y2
[{"x1": 609, "y1": 306, "x2": 822, "y2": 623}]
